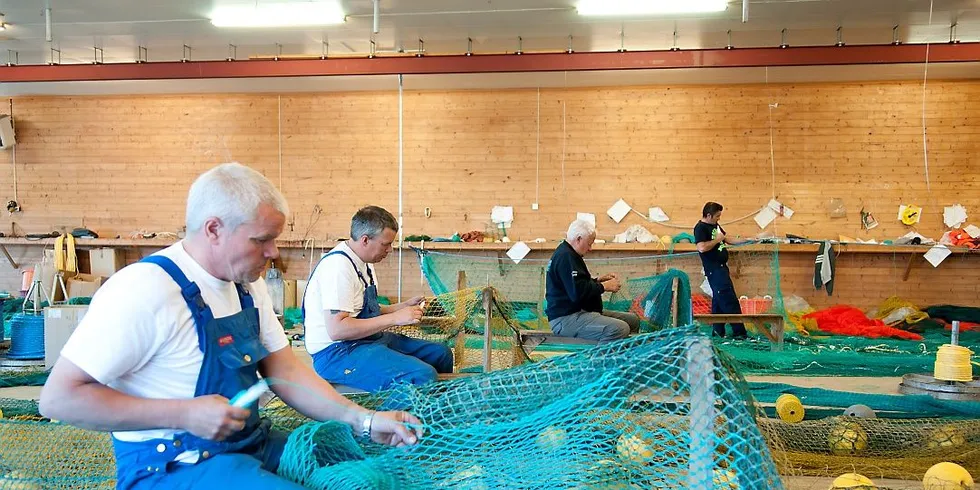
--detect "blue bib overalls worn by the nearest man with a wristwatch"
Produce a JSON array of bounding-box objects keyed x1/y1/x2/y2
[{"x1": 112, "y1": 255, "x2": 303, "y2": 490}]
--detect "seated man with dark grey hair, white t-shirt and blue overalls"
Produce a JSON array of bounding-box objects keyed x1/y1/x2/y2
[{"x1": 303, "y1": 206, "x2": 453, "y2": 392}]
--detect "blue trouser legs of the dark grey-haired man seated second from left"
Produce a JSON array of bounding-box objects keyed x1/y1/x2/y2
[{"x1": 313, "y1": 332, "x2": 453, "y2": 393}]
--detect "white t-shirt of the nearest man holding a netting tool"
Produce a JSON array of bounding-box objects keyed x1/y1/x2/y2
[{"x1": 61, "y1": 242, "x2": 289, "y2": 462}]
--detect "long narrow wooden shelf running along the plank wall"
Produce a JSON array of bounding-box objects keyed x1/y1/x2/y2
[{"x1": 0, "y1": 237, "x2": 980, "y2": 254}]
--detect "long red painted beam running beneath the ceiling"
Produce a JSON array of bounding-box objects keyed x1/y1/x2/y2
[{"x1": 0, "y1": 43, "x2": 980, "y2": 82}]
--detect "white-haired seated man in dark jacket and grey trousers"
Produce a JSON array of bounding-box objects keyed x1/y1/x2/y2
[{"x1": 545, "y1": 220, "x2": 640, "y2": 344}]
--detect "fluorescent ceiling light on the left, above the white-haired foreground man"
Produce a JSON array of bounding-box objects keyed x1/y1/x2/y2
[{"x1": 211, "y1": 1, "x2": 344, "y2": 27}]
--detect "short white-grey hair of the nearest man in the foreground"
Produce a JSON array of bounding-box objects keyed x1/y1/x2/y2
[{"x1": 185, "y1": 162, "x2": 289, "y2": 234}]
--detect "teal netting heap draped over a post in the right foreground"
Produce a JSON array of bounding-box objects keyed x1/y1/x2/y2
[{"x1": 280, "y1": 331, "x2": 782, "y2": 490}]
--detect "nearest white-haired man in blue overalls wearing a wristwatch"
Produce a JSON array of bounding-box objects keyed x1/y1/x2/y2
[{"x1": 40, "y1": 164, "x2": 420, "y2": 490}]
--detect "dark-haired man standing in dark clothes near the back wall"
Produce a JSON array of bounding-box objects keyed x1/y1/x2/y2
[{"x1": 694, "y1": 202, "x2": 746, "y2": 339}]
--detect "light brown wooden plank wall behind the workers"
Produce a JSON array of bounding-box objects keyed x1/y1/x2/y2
[{"x1": 0, "y1": 81, "x2": 980, "y2": 306}]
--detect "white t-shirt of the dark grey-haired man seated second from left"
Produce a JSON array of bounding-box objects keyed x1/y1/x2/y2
[{"x1": 303, "y1": 242, "x2": 378, "y2": 355}]
